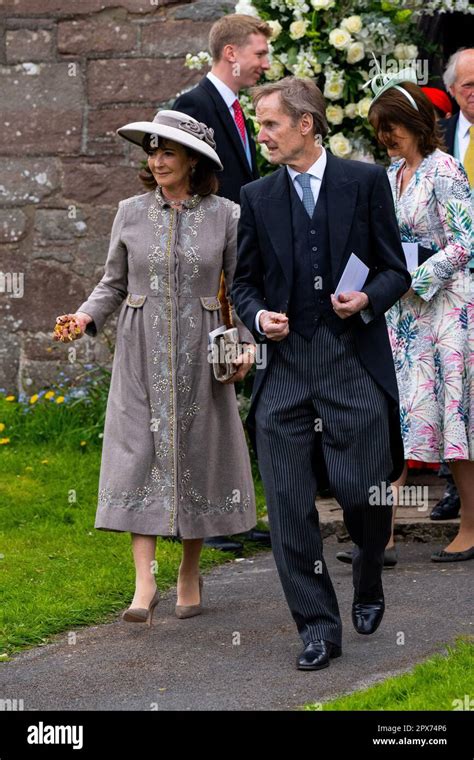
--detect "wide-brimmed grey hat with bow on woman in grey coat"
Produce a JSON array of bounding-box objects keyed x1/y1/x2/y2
[{"x1": 117, "y1": 111, "x2": 223, "y2": 169}]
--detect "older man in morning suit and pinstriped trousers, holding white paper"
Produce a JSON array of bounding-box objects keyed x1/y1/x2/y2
[{"x1": 232, "y1": 77, "x2": 411, "y2": 670}]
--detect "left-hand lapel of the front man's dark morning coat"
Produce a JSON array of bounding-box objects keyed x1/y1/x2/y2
[{"x1": 260, "y1": 166, "x2": 293, "y2": 288}]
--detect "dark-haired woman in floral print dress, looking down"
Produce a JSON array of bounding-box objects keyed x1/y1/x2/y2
[{"x1": 369, "y1": 79, "x2": 474, "y2": 562}]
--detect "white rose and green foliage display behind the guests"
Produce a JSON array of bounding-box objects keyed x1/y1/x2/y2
[{"x1": 186, "y1": 0, "x2": 474, "y2": 168}]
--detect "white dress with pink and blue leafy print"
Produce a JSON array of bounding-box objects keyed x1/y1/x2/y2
[{"x1": 386, "y1": 145, "x2": 474, "y2": 462}]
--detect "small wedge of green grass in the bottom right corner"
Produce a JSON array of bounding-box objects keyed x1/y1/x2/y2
[{"x1": 304, "y1": 639, "x2": 474, "y2": 710}]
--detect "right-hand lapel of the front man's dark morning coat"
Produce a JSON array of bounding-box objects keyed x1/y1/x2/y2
[{"x1": 325, "y1": 152, "x2": 359, "y2": 287}]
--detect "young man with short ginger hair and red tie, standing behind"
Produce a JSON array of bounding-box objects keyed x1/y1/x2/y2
[{"x1": 173, "y1": 14, "x2": 271, "y2": 552}]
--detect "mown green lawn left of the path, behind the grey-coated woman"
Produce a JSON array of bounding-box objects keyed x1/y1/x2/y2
[{"x1": 0, "y1": 444, "x2": 265, "y2": 659}]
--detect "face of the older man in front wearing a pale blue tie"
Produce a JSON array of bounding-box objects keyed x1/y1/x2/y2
[{"x1": 256, "y1": 92, "x2": 312, "y2": 166}]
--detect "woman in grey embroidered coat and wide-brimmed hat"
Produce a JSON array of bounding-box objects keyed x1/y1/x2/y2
[{"x1": 53, "y1": 111, "x2": 256, "y2": 620}]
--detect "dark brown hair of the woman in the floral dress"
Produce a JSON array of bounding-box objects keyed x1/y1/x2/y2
[{"x1": 368, "y1": 82, "x2": 446, "y2": 157}]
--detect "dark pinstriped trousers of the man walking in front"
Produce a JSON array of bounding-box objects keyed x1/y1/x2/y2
[{"x1": 255, "y1": 320, "x2": 392, "y2": 646}]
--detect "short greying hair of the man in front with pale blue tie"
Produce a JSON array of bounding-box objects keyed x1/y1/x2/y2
[{"x1": 250, "y1": 77, "x2": 329, "y2": 137}]
